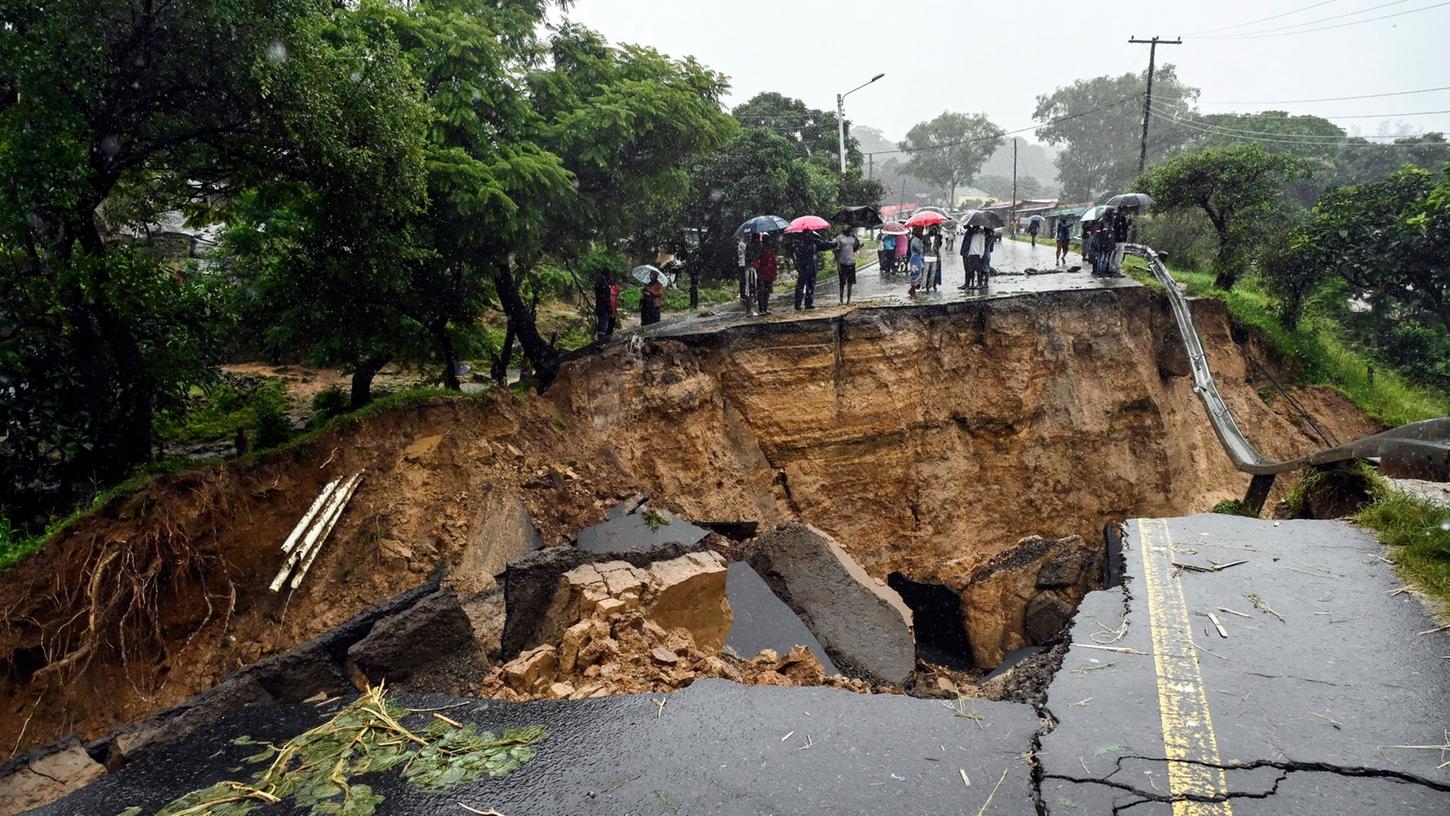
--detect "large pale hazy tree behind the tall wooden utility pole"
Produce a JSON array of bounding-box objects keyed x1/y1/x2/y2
[{"x1": 1032, "y1": 65, "x2": 1199, "y2": 201}]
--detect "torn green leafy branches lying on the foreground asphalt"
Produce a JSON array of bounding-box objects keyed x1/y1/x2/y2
[{"x1": 139, "y1": 686, "x2": 547, "y2": 816}]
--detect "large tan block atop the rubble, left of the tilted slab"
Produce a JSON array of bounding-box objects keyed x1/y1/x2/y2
[{"x1": 645, "y1": 552, "x2": 734, "y2": 654}]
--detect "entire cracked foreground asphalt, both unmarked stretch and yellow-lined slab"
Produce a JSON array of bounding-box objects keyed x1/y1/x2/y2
[{"x1": 22, "y1": 515, "x2": 1450, "y2": 816}]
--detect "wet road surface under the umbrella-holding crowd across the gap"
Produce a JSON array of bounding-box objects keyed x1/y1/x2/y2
[{"x1": 643, "y1": 241, "x2": 1141, "y2": 342}]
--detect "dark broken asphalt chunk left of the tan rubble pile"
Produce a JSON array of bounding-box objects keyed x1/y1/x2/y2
[{"x1": 347, "y1": 588, "x2": 477, "y2": 686}]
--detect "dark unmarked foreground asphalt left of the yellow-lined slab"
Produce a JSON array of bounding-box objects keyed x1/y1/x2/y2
[{"x1": 35, "y1": 680, "x2": 1038, "y2": 816}]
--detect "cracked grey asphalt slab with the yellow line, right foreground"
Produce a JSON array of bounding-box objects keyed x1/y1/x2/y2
[{"x1": 1040, "y1": 515, "x2": 1450, "y2": 816}]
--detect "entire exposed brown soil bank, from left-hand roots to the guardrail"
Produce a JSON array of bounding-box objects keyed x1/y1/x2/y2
[{"x1": 0, "y1": 288, "x2": 1351, "y2": 749}]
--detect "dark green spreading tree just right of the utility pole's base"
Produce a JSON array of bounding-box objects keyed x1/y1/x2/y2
[{"x1": 1135, "y1": 143, "x2": 1309, "y2": 288}]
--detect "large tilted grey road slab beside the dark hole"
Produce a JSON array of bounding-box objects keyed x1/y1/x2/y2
[{"x1": 750, "y1": 523, "x2": 916, "y2": 686}]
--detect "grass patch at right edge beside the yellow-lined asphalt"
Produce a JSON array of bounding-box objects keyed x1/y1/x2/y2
[{"x1": 1354, "y1": 483, "x2": 1450, "y2": 613}]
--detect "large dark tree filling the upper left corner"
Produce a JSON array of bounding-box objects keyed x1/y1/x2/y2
[{"x1": 0, "y1": 0, "x2": 422, "y2": 513}]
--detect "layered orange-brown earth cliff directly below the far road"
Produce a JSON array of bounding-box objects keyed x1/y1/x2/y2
[{"x1": 550, "y1": 288, "x2": 1351, "y2": 577}]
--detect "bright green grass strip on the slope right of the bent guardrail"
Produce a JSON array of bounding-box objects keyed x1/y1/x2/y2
[{"x1": 1125, "y1": 258, "x2": 1450, "y2": 426}]
